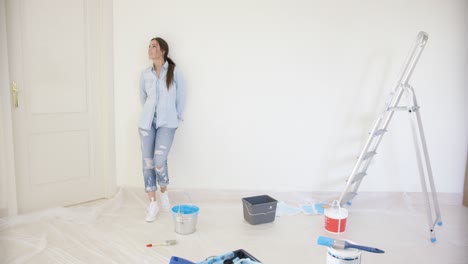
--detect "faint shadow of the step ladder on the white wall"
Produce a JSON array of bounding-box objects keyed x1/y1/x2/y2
[{"x1": 320, "y1": 50, "x2": 394, "y2": 191}]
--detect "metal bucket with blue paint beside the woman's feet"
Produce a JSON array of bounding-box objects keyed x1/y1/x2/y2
[{"x1": 171, "y1": 204, "x2": 200, "y2": 235}]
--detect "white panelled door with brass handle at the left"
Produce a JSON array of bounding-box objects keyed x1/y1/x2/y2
[{"x1": 6, "y1": 0, "x2": 112, "y2": 213}]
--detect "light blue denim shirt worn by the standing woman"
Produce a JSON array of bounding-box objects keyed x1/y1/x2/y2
[{"x1": 138, "y1": 61, "x2": 186, "y2": 130}]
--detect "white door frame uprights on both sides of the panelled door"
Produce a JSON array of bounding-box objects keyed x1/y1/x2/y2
[{"x1": 0, "y1": 0, "x2": 117, "y2": 217}]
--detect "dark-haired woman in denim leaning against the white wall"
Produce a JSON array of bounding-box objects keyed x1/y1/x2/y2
[{"x1": 138, "y1": 38, "x2": 185, "y2": 222}]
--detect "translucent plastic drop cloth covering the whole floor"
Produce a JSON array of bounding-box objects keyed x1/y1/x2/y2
[{"x1": 0, "y1": 188, "x2": 468, "y2": 264}]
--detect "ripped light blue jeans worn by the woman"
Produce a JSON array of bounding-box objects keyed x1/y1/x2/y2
[{"x1": 138, "y1": 118, "x2": 177, "y2": 192}]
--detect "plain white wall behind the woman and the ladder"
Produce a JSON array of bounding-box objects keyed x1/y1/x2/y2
[{"x1": 114, "y1": 0, "x2": 468, "y2": 193}]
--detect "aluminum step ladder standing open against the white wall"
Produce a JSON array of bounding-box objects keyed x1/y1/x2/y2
[{"x1": 338, "y1": 31, "x2": 442, "y2": 243}]
